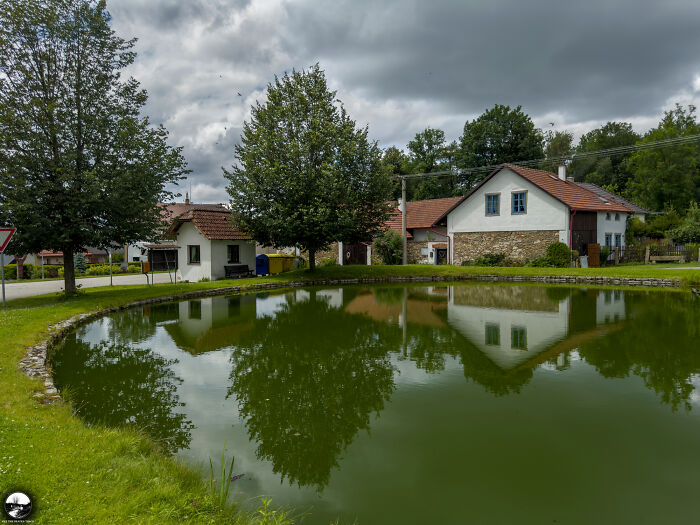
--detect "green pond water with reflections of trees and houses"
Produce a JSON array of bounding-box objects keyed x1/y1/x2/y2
[{"x1": 52, "y1": 284, "x2": 700, "y2": 525}]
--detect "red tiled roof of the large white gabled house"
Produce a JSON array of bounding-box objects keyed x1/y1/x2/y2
[{"x1": 504, "y1": 164, "x2": 632, "y2": 213}]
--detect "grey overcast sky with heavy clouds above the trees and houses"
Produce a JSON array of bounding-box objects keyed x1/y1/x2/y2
[{"x1": 108, "y1": 0, "x2": 700, "y2": 202}]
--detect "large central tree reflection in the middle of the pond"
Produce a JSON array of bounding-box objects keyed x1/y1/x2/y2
[{"x1": 229, "y1": 292, "x2": 400, "y2": 490}]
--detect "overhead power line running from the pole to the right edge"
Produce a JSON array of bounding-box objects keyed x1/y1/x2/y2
[{"x1": 394, "y1": 134, "x2": 700, "y2": 179}]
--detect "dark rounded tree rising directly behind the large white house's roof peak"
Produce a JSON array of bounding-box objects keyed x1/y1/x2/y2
[{"x1": 456, "y1": 104, "x2": 544, "y2": 189}]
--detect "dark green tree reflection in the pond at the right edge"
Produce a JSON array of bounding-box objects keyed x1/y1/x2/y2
[{"x1": 579, "y1": 293, "x2": 700, "y2": 411}]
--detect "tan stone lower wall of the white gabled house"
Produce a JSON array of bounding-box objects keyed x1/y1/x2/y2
[{"x1": 454, "y1": 230, "x2": 559, "y2": 265}]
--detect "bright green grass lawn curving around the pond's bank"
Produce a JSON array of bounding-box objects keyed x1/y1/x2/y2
[{"x1": 0, "y1": 265, "x2": 700, "y2": 524}]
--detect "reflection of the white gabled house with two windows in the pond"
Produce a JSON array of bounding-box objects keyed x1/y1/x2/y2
[{"x1": 447, "y1": 286, "x2": 625, "y2": 370}]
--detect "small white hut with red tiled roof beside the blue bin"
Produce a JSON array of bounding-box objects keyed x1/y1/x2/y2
[{"x1": 168, "y1": 204, "x2": 255, "y2": 282}]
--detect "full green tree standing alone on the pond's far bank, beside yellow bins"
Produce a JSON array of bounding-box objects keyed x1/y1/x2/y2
[{"x1": 224, "y1": 64, "x2": 391, "y2": 270}]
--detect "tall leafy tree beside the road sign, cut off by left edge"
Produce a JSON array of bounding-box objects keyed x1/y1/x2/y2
[{"x1": 0, "y1": 0, "x2": 187, "y2": 294}]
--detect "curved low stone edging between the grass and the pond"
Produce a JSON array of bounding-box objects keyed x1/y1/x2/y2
[{"x1": 19, "y1": 275, "x2": 680, "y2": 404}]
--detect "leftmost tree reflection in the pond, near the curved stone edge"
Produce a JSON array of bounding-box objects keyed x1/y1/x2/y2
[{"x1": 51, "y1": 335, "x2": 193, "y2": 453}]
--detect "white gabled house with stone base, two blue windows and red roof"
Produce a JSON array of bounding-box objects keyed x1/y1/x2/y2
[{"x1": 442, "y1": 164, "x2": 645, "y2": 264}]
